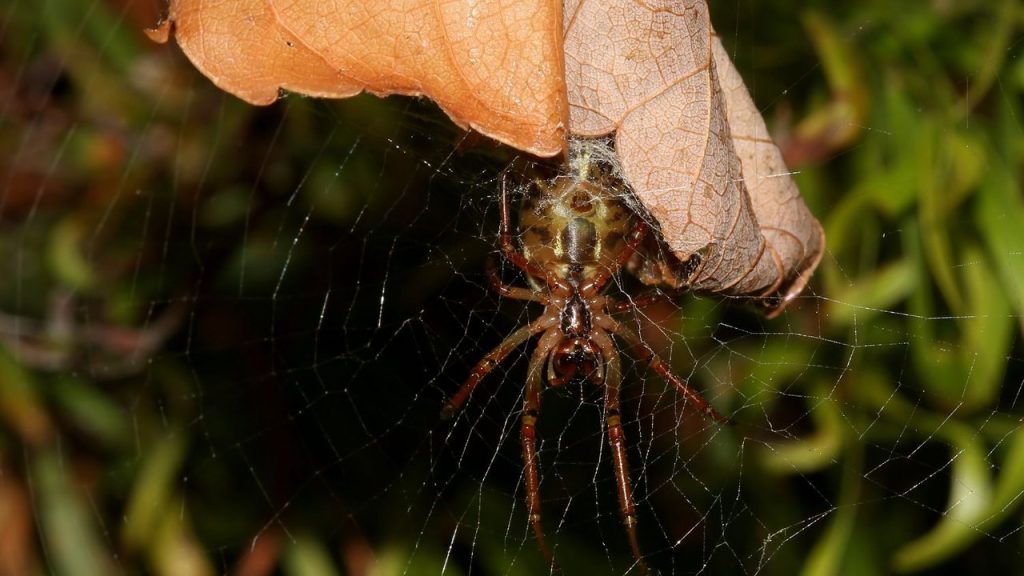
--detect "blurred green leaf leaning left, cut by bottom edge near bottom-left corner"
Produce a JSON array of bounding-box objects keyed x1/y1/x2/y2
[{"x1": 31, "y1": 448, "x2": 121, "y2": 576}]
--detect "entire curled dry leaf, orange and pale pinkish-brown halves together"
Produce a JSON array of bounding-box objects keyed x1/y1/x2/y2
[{"x1": 153, "y1": 0, "x2": 824, "y2": 314}]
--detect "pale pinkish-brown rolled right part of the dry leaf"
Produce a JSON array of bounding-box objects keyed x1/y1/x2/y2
[{"x1": 565, "y1": 0, "x2": 823, "y2": 312}]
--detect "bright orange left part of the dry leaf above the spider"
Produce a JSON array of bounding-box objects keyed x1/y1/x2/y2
[{"x1": 155, "y1": 0, "x2": 566, "y2": 156}]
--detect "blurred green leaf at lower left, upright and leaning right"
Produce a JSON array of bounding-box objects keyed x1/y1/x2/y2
[{"x1": 121, "y1": 430, "x2": 187, "y2": 549}]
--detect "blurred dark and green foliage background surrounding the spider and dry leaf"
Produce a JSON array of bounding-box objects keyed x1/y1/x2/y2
[{"x1": 0, "y1": 0, "x2": 1024, "y2": 576}]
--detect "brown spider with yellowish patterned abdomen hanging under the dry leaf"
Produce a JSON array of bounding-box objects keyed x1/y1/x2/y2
[{"x1": 442, "y1": 142, "x2": 726, "y2": 574}]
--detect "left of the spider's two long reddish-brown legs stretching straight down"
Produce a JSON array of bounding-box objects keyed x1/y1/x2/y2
[{"x1": 520, "y1": 327, "x2": 562, "y2": 566}]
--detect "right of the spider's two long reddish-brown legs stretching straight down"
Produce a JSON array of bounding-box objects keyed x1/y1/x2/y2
[{"x1": 591, "y1": 328, "x2": 648, "y2": 575}]
